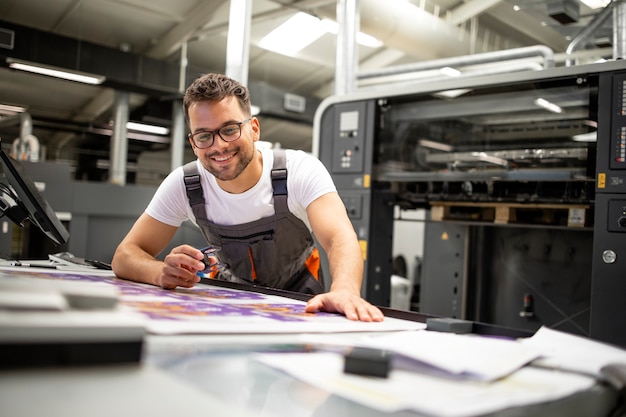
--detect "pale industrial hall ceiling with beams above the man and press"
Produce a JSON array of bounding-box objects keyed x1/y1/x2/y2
[{"x1": 0, "y1": 0, "x2": 612, "y2": 179}]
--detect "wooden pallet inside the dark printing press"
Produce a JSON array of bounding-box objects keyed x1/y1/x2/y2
[{"x1": 430, "y1": 201, "x2": 590, "y2": 227}]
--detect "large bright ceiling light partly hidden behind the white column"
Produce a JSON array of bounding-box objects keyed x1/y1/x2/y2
[{"x1": 259, "y1": 12, "x2": 383, "y2": 56}]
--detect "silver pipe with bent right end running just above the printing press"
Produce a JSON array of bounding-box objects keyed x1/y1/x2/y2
[{"x1": 357, "y1": 45, "x2": 554, "y2": 80}]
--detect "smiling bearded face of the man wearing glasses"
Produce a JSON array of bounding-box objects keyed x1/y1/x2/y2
[{"x1": 188, "y1": 97, "x2": 259, "y2": 181}]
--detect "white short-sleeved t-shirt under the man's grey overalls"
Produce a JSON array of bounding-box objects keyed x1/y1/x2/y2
[{"x1": 146, "y1": 148, "x2": 336, "y2": 230}]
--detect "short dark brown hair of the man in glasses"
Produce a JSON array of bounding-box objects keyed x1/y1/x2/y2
[{"x1": 183, "y1": 73, "x2": 250, "y2": 124}]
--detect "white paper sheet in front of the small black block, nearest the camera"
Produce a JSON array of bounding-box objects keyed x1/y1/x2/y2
[{"x1": 256, "y1": 352, "x2": 594, "y2": 417}]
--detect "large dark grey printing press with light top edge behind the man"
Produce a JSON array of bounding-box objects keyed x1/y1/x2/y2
[{"x1": 314, "y1": 61, "x2": 626, "y2": 346}]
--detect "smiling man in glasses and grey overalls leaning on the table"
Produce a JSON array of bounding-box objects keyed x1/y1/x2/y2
[{"x1": 112, "y1": 74, "x2": 383, "y2": 321}]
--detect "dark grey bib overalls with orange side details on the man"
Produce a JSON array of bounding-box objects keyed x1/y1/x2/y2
[{"x1": 184, "y1": 150, "x2": 324, "y2": 294}]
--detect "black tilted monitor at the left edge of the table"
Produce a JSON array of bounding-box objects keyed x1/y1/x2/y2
[{"x1": 0, "y1": 149, "x2": 70, "y2": 245}]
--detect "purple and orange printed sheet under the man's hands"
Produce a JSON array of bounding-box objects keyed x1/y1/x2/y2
[{"x1": 0, "y1": 268, "x2": 425, "y2": 334}]
